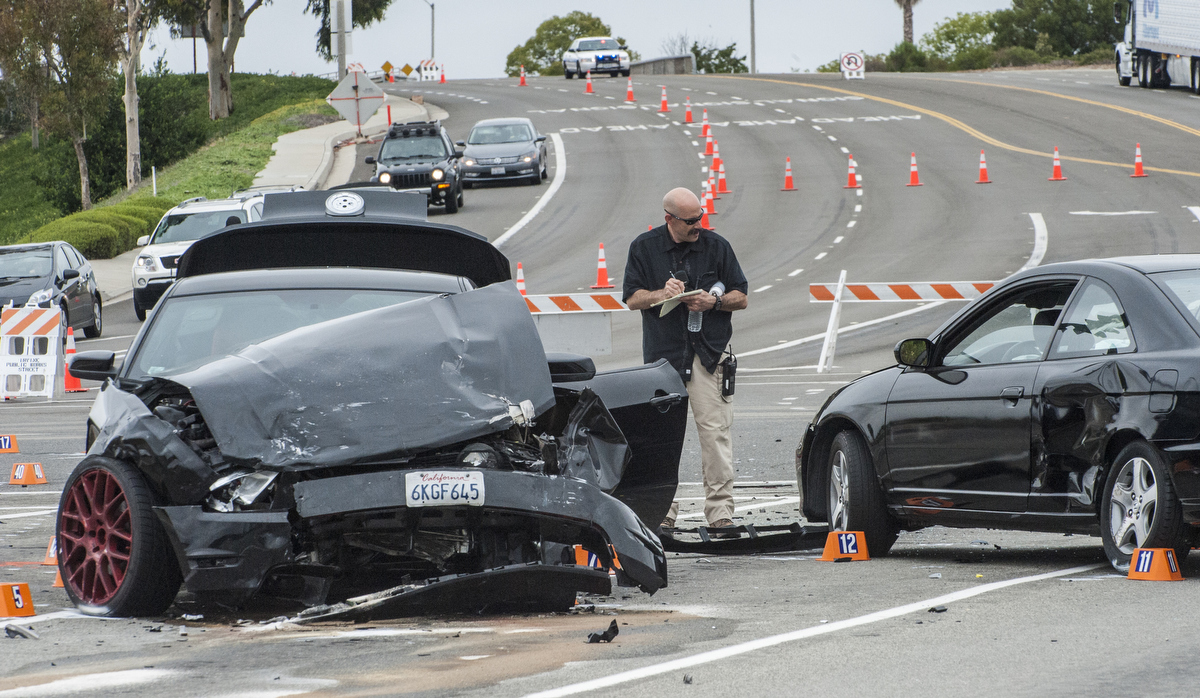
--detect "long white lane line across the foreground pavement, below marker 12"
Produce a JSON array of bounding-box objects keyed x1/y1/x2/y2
[{"x1": 527, "y1": 564, "x2": 1104, "y2": 698}]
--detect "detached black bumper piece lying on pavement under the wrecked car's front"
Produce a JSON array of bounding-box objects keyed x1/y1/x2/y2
[{"x1": 280, "y1": 562, "x2": 612, "y2": 624}]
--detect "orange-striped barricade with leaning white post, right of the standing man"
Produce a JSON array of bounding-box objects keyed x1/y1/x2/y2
[{"x1": 809, "y1": 270, "x2": 996, "y2": 373}]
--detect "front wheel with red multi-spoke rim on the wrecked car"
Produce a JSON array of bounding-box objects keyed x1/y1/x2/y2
[{"x1": 55, "y1": 456, "x2": 182, "y2": 618}]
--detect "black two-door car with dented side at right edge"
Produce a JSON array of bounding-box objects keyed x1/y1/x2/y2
[{"x1": 796, "y1": 255, "x2": 1200, "y2": 571}]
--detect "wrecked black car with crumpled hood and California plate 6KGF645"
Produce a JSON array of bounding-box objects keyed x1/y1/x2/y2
[{"x1": 63, "y1": 189, "x2": 688, "y2": 616}]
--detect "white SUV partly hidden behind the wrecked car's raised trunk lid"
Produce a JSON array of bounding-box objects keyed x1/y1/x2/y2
[{"x1": 133, "y1": 193, "x2": 267, "y2": 320}]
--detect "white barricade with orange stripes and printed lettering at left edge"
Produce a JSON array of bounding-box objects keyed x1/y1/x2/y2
[{"x1": 0, "y1": 308, "x2": 62, "y2": 398}]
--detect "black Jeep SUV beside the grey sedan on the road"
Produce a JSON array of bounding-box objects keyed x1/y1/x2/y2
[{"x1": 365, "y1": 121, "x2": 463, "y2": 213}]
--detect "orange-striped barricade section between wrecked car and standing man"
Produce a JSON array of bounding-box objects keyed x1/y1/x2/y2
[{"x1": 524, "y1": 293, "x2": 629, "y2": 356}]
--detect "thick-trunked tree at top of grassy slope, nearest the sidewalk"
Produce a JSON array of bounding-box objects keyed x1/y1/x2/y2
[{"x1": 162, "y1": 0, "x2": 270, "y2": 120}]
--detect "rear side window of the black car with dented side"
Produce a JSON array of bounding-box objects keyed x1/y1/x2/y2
[{"x1": 1050, "y1": 279, "x2": 1134, "y2": 359}]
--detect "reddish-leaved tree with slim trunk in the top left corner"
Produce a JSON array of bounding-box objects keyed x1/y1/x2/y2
[{"x1": 0, "y1": 0, "x2": 120, "y2": 210}]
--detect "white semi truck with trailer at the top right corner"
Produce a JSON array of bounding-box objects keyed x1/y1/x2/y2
[{"x1": 1112, "y1": 0, "x2": 1200, "y2": 95}]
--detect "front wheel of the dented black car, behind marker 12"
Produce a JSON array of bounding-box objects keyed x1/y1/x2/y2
[{"x1": 826, "y1": 429, "x2": 900, "y2": 558}]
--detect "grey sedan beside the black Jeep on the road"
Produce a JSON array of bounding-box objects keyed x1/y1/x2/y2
[{"x1": 458, "y1": 118, "x2": 548, "y2": 187}]
